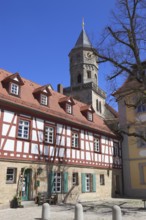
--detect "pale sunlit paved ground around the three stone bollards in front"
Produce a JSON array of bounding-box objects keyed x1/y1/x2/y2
[{"x1": 0, "y1": 199, "x2": 146, "y2": 220}]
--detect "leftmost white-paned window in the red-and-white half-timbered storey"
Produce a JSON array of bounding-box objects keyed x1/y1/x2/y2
[{"x1": 18, "y1": 119, "x2": 30, "y2": 139}]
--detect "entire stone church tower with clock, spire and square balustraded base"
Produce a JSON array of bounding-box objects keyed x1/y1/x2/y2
[{"x1": 63, "y1": 23, "x2": 110, "y2": 118}]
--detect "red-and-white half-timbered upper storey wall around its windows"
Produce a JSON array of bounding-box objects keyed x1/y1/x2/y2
[{"x1": 0, "y1": 107, "x2": 121, "y2": 168}]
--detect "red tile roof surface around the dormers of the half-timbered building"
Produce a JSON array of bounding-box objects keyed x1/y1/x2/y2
[{"x1": 0, "y1": 69, "x2": 115, "y2": 136}]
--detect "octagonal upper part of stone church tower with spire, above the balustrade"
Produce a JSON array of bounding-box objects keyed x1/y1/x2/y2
[{"x1": 69, "y1": 21, "x2": 98, "y2": 87}]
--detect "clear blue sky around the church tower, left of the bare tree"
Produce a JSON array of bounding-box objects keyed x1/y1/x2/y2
[{"x1": 0, "y1": 0, "x2": 116, "y2": 105}]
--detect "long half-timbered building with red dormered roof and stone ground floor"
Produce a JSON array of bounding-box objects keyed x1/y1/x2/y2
[{"x1": 0, "y1": 69, "x2": 122, "y2": 203}]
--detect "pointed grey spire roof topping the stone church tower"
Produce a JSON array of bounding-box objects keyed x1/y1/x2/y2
[{"x1": 75, "y1": 18, "x2": 92, "y2": 48}]
